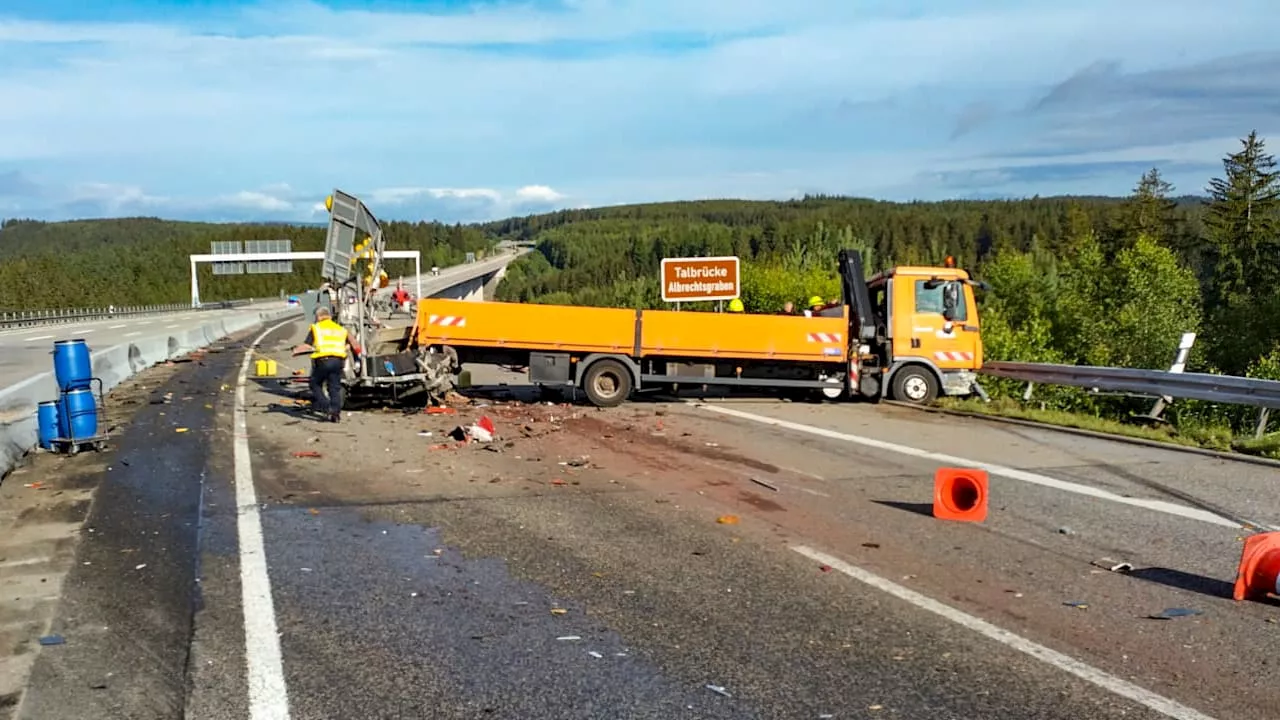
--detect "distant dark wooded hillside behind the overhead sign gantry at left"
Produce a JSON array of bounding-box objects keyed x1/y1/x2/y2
[{"x1": 0, "y1": 212, "x2": 495, "y2": 310}]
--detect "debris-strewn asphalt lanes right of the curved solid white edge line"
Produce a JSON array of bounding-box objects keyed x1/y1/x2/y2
[{"x1": 193, "y1": 322, "x2": 1280, "y2": 719}]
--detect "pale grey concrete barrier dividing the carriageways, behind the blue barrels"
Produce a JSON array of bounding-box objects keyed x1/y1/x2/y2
[{"x1": 0, "y1": 307, "x2": 301, "y2": 482}]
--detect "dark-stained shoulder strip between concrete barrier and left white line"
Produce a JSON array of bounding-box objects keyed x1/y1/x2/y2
[{"x1": 20, "y1": 335, "x2": 247, "y2": 720}]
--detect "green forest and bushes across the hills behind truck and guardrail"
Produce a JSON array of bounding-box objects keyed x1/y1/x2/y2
[{"x1": 0, "y1": 133, "x2": 1280, "y2": 457}]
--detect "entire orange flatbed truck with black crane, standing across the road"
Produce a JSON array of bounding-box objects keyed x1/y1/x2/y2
[{"x1": 413, "y1": 250, "x2": 986, "y2": 407}]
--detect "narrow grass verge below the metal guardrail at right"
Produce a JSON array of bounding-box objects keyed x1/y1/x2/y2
[{"x1": 938, "y1": 397, "x2": 1280, "y2": 460}]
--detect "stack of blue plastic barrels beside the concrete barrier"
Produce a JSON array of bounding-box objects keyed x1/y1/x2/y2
[{"x1": 37, "y1": 340, "x2": 99, "y2": 450}]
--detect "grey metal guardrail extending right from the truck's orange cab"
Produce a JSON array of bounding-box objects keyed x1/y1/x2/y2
[{"x1": 979, "y1": 361, "x2": 1280, "y2": 409}]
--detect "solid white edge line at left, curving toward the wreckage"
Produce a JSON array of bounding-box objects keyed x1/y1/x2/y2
[{"x1": 234, "y1": 320, "x2": 292, "y2": 720}]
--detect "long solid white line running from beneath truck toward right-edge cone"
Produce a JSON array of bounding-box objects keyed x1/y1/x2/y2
[{"x1": 696, "y1": 404, "x2": 1249, "y2": 529}]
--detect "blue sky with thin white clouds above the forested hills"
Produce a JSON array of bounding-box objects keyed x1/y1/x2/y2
[{"x1": 0, "y1": 0, "x2": 1280, "y2": 222}]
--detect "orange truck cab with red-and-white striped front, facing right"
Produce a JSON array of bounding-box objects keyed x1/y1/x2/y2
[{"x1": 864, "y1": 259, "x2": 982, "y2": 404}]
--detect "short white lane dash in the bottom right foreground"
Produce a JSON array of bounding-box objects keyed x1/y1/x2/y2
[{"x1": 791, "y1": 546, "x2": 1213, "y2": 720}]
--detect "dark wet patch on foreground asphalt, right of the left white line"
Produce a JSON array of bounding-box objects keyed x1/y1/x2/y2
[{"x1": 264, "y1": 509, "x2": 758, "y2": 720}]
